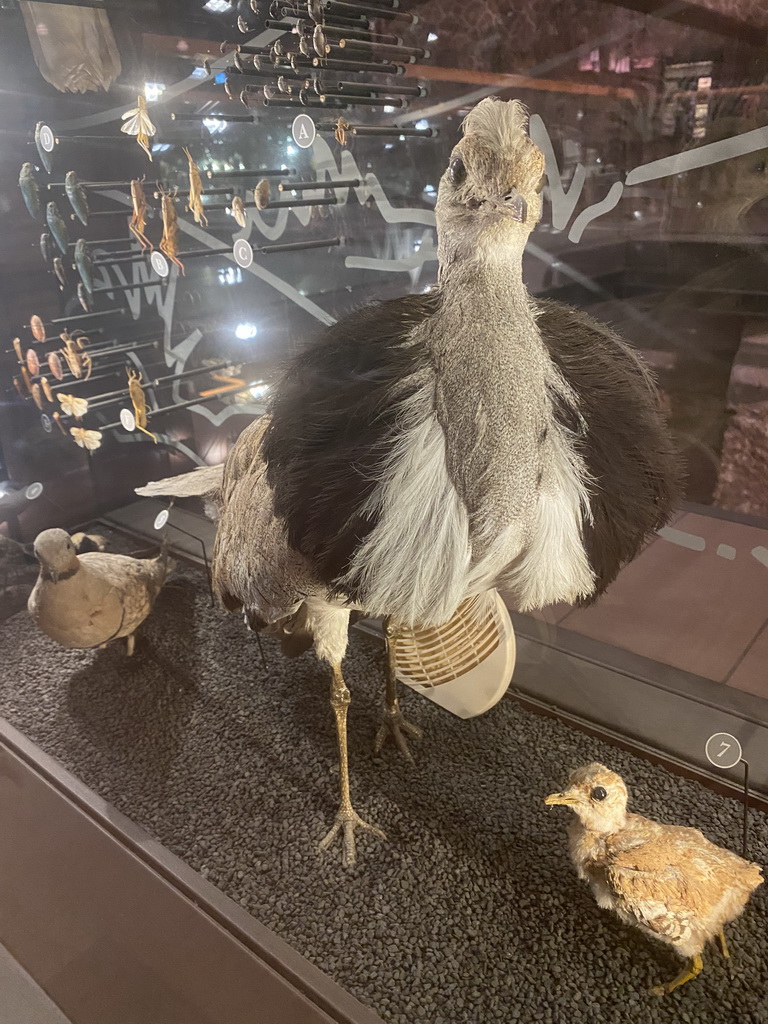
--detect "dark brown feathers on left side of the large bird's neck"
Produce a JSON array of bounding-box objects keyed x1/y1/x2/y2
[{"x1": 262, "y1": 295, "x2": 438, "y2": 597}]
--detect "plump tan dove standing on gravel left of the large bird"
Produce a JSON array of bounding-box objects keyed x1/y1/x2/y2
[{"x1": 28, "y1": 529, "x2": 173, "y2": 654}]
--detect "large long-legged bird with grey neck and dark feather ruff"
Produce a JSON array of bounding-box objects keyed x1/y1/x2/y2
[{"x1": 138, "y1": 99, "x2": 678, "y2": 860}]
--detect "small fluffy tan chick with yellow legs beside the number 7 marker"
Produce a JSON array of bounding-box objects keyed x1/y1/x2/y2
[{"x1": 546, "y1": 763, "x2": 763, "y2": 995}]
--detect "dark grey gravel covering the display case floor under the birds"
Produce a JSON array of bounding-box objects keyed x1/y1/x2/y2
[{"x1": 0, "y1": 557, "x2": 768, "y2": 1024}]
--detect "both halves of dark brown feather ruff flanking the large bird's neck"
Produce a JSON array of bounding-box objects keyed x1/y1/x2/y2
[{"x1": 262, "y1": 293, "x2": 681, "y2": 603}]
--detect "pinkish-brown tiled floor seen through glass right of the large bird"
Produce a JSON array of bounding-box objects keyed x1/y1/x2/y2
[{"x1": 537, "y1": 513, "x2": 768, "y2": 698}]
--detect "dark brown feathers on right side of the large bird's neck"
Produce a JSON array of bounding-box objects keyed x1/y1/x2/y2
[{"x1": 536, "y1": 299, "x2": 682, "y2": 604}]
